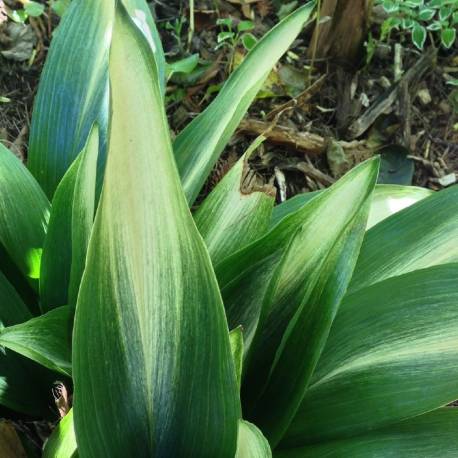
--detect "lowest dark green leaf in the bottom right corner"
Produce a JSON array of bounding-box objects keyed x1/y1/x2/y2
[{"x1": 275, "y1": 407, "x2": 458, "y2": 458}]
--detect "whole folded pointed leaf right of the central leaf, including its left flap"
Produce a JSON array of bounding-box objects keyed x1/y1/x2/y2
[{"x1": 217, "y1": 160, "x2": 378, "y2": 443}]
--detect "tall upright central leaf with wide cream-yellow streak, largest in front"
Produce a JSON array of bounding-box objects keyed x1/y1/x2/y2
[{"x1": 73, "y1": 4, "x2": 240, "y2": 458}]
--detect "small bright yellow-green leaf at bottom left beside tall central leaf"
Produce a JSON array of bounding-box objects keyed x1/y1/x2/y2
[{"x1": 43, "y1": 409, "x2": 77, "y2": 458}]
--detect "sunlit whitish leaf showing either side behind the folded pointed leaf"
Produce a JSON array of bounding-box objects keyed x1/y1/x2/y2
[{"x1": 270, "y1": 184, "x2": 434, "y2": 229}]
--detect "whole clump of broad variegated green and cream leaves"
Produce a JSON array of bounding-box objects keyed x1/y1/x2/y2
[{"x1": 0, "y1": 0, "x2": 458, "y2": 458}]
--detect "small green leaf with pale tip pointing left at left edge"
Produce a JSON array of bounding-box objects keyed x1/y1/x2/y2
[{"x1": 0, "y1": 306, "x2": 73, "y2": 376}]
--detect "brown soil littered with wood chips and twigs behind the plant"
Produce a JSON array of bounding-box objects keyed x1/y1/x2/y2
[{"x1": 0, "y1": 0, "x2": 458, "y2": 204}]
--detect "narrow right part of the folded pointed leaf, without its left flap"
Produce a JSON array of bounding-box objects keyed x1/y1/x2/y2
[{"x1": 243, "y1": 159, "x2": 379, "y2": 446}]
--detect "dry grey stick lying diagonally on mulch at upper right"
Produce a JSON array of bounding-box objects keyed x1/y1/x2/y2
[{"x1": 348, "y1": 48, "x2": 437, "y2": 138}]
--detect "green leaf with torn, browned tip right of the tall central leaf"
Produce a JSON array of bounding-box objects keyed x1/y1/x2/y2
[{"x1": 194, "y1": 137, "x2": 275, "y2": 265}]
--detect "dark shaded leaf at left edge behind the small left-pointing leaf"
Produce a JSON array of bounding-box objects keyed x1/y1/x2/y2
[{"x1": 0, "y1": 272, "x2": 51, "y2": 415}]
